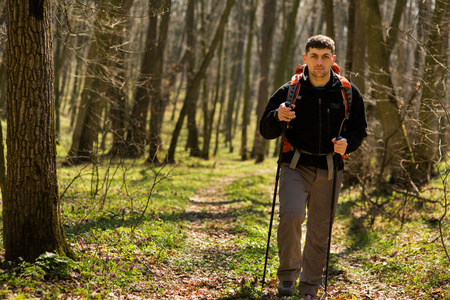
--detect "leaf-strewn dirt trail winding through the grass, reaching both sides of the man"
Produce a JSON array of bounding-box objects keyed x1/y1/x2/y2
[{"x1": 145, "y1": 175, "x2": 421, "y2": 299}]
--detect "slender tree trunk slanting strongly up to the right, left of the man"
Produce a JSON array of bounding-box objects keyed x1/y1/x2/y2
[{"x1": 165, "y1": 0, "x2": 236, "y2": 163}]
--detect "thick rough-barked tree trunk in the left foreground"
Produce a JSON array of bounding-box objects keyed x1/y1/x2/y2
[{"x1": 3, "y1": 0, "x2": 73, "y2": 262}]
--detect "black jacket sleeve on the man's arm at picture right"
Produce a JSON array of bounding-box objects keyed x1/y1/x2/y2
[{"x1": 343, "y1": 84, "x2": 367, "y2": 153}]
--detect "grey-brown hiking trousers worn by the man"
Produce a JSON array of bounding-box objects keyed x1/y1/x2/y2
[{"x1": 277, "y1": 164, "x2": 343, "y2": 295}]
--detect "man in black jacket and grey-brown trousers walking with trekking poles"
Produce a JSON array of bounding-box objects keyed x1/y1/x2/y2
[{"x1": 260, "y1": 35, "x2": 367, "y2": 299}]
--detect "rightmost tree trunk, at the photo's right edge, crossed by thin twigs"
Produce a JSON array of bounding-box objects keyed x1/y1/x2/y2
[{"x1": 412, "y1": 0, "x2": 449, "y2": 185}]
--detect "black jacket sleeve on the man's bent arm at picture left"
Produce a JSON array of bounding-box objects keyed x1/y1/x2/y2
[{"x1": 259, "y1": 84, "x2": 289, "y2": 139}]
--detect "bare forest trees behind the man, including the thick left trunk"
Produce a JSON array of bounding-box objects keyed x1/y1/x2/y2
[{"x1": 0, "y1": 0, "x2": 450, "y2": 298}]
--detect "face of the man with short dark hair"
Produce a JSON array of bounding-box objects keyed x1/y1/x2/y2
[{"x1": 303, "y1": 48, "x2": 336, "y2": 79}]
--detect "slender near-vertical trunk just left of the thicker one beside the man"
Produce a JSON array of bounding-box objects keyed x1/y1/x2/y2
[{"x1": 241, "y1": 0, "x2": 256, "y2": 160}]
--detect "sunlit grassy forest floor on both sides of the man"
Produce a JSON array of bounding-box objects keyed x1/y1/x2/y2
[{"x1": 0, "y1": 145, "x2": 450, "y2": 299}]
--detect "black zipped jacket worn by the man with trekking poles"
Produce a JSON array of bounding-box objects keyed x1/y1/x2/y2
[{"x1": 260, "y1": 67, "x2": 367, "y2": 169}]
